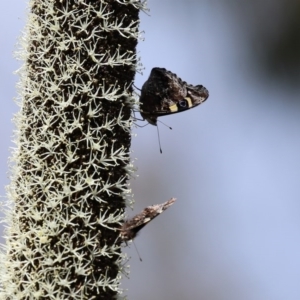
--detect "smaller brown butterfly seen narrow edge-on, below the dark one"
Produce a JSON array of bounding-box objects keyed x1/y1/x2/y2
[{"x1": 120, "y1": 198, "x2": 176, "y2": 242}]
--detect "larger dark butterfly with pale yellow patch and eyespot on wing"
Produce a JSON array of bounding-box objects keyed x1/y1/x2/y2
[{"x1": 140, "y1": 68, "x2": 209, "y2": 126}]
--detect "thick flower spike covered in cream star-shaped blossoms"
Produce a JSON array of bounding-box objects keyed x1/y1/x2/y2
[{"x1": 0, "y1": 0, "x2": 145, "y2": 299}]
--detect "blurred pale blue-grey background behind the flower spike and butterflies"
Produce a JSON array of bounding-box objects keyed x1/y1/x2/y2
[{"x1": 0, "y1": 0, "x2": 300, "y2": 300}]
